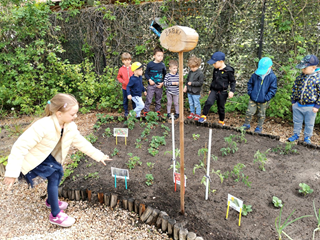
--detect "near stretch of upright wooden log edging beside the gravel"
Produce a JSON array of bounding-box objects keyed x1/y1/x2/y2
[{"x1": 58, "y1": 187, "x2": 203, "y2": 240}]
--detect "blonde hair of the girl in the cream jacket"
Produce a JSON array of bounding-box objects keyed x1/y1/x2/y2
[{"x1": 44, "y1": 93, "x2": 79, "y2": 117}]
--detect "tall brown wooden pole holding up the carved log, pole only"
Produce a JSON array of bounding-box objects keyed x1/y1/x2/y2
[{"x1": 179, "y1": 52, "x2": 184, "y2": 215}]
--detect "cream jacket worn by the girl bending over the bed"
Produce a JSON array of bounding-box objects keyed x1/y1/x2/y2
[{"x1": 5, "y1": 115, "x2": 104, "y2": 178}]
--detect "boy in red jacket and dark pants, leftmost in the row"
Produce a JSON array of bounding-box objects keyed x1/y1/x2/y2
[{"x1": 117, "y1": 52, "x2": 136, "y2": 117}]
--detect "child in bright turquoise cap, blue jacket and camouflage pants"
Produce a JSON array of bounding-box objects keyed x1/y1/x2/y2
[{"x1": 243, "y1": 57, "x2": 277, "y2": 133}]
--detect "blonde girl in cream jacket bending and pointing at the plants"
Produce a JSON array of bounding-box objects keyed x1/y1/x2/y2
[{"x1": 4, "y1": 93, "x2": 112, "y2": 227}]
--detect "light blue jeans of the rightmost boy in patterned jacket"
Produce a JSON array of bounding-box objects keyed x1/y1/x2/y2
[{"x1": 292, "y1": 103, "x2": 317, "y2": 137}]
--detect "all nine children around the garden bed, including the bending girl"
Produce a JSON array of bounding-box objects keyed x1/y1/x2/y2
[{"x1": 4, "y1": 48, "x2": 320, "y2": 227}]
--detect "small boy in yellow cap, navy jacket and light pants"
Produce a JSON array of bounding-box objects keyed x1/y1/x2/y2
[{"x1": 127, "y1": 62, "x2": 147, "y2": 118}]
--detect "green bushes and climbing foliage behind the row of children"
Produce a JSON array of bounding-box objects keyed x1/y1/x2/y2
[{"x1": 0, "y1": 0, "x2": 320, "y2": 122}]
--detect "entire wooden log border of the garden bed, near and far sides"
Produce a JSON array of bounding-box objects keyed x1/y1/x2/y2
[{"x1": 58, "y1": 117, "x2": 320, "y2": 240}]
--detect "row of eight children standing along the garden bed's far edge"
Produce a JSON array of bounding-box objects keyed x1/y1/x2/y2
[{"x1": 117, "y1": 48, "x2": 320, "y2": 143}]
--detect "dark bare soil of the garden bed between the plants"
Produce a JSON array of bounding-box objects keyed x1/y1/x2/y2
[{"x1": 64, "y1": 119, "x2": 320, "y2": 240}]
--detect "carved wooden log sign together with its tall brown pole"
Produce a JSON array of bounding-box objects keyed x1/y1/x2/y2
[{"x1": 160, "y1": 26, "x2": 199, "y2": 214}]
